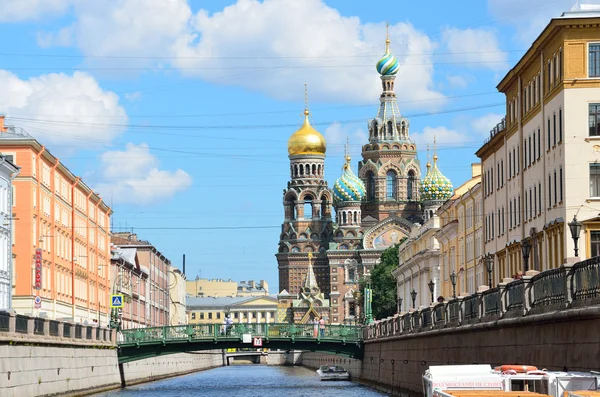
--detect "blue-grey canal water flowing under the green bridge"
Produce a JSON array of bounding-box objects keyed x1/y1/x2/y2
[{"x1": 95, "y1": 365, "x2": 386, "y2": 397}]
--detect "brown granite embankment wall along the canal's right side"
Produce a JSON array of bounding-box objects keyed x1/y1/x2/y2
[{"x1": 358, "y1": 306, "x2": 600, "y2": 396}]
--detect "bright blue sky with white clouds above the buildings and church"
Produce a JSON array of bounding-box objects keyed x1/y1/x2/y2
[{"x1": 0, "y1": 0, "x2": 589, "y2": 293}]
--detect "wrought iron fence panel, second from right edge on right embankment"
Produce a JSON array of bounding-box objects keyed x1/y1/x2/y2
[{"x1": 529, "y1": 266, "x2": 567, "y2": 307}]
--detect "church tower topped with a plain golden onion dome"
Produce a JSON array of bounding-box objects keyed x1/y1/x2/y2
[{"x1": 276, "y1": 89, "x2": 333, "y2": 295}]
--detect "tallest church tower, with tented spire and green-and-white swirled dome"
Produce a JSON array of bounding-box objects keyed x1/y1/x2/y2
[{"x1": 358, "y1": 27, "x2": 421, "y2": 226}]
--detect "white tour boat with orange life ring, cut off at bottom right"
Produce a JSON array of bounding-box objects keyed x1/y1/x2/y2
[{"x1": 423, "y1": 365, "x2": 598, "y2": 397}]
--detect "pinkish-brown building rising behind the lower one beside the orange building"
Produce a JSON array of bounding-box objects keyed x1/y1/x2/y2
[{"x1": 111, "y1": 233, "x2": 171, "y2": 327}]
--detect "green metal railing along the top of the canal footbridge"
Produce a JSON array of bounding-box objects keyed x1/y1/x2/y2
[{"x1": 119, "y1": 323, "x2": 366, "y2": 344}]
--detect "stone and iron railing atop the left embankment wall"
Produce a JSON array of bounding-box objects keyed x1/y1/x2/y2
[{"x1": 0, "y1": 312, "x2": 117, "y2": 346}]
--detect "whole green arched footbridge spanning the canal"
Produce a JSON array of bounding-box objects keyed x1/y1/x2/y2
[{"x1": 118, "y1": 323, "x2": 363, "y2": 364}]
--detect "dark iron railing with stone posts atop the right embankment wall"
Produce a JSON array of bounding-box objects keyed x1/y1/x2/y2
[{"x1": 364, "y1": 257, "x2": 600, "y2": 340}]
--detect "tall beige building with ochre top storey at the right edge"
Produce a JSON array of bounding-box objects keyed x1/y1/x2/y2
[{"x1": 477, "y1": 6, "x2": 600, "y2": 284}]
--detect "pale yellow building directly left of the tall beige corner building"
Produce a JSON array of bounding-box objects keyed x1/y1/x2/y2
[{"x1": 436, "y1": 164, "x2": 485, "y2": 298}]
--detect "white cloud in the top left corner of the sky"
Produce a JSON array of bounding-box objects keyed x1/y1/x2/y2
[{"x1": 0, "y1": 0, "x2": 73, "y2": 22}]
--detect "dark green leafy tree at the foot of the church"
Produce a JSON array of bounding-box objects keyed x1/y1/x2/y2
[{"x1": 359, "y1": 240, "x2": 404, "y2": 319}]
